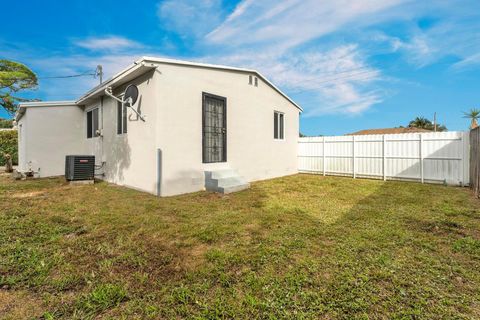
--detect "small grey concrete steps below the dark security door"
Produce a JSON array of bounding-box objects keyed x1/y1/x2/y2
[{"x1": 205, "y1": 169, "x2": 250, "y2": 193}]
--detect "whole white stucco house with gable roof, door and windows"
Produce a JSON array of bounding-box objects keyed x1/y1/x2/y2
[{"x1": 16, "y1": 57, "x2": 302, "y2": 196}]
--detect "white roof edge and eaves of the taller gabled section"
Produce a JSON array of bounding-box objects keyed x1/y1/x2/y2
[{"x1": 76, "y1": 57, "x2": 303, "y2": 111}]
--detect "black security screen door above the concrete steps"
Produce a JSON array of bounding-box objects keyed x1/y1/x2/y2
[{"x1": 202, "y1": 93, "x2": 227, "y2": 163}]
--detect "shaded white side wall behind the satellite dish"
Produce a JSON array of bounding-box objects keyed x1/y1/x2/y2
[{"x1": 79, "y1": 71, "x2": 158, "y2": 194}]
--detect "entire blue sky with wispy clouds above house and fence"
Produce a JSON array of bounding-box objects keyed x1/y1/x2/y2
[{"x1": 0, "y1": 0, "x2": 480, "y2": 135}]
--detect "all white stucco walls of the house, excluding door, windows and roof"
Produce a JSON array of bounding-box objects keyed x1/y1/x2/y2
[{"x1": 19, "y1": 64, "x2": 299, "y2": 196}]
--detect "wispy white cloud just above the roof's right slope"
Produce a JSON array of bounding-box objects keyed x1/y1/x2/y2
[{"x1": 204, "y1": 44, "x2": 382, "y2": 116}]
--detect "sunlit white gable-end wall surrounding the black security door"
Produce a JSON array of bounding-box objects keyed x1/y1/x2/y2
[{"x1": 156, "y1": 64, "x2": 299, "y2": 196}]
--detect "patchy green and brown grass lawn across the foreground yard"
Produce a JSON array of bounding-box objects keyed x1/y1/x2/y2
[{"x1": 0, "y1": 175, "x2": 480, "y2": 319}]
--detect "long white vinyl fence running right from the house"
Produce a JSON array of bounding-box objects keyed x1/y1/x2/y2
[{"x1": 298, "y1": 131, "x2": 469, "y2": 185}]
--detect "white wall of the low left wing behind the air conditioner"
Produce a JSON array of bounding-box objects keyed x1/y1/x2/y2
[{"x1": 18, "y1": 106, "x2": 84, "y2": 177}]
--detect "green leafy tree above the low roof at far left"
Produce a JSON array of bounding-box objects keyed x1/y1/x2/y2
[{"x1": 0, "y1": 59, "x2": 38, "y2": 115}]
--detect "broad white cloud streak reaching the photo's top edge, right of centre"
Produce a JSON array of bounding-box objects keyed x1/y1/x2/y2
[{"x1": 207, "y1": 0, "x2": 406, "y2": 48}]
